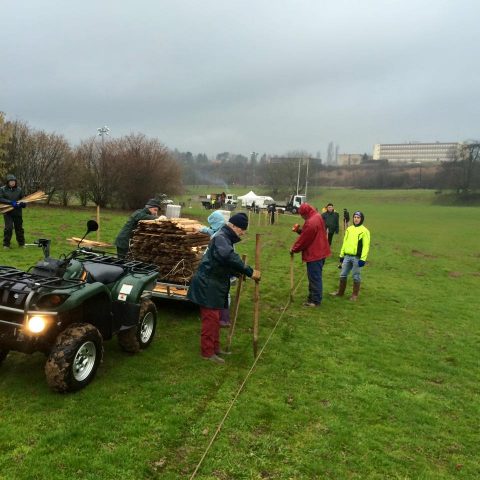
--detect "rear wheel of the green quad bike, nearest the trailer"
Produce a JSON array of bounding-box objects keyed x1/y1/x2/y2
[{"x1": 118, "y1": 300, "x2": 157, "y2": 353}]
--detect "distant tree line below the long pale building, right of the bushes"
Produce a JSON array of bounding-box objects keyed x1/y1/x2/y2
[{"x1": 173, "y1": 141, "x2": 480, "y2": 195}]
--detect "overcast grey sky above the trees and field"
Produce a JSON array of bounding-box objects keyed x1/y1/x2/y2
[{"x1": 0, "y1": 0, "x2": 480, "y2": 158}]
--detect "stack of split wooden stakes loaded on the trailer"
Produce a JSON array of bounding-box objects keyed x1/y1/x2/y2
[{"x1": 130, "y1": 218, "x2": 210, "y2": 285}]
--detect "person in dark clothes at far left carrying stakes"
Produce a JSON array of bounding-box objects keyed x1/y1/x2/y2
[{"x1": 0, "y1": 174, "x2": 27, "y2": 249}]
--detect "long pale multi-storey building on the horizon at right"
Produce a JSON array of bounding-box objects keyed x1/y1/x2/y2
[{"x1": 373, "y1": 142, "x2": 460, "y2": 162}]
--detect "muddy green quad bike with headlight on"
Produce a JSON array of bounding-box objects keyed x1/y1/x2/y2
[{"x1": 0, "y1": 220, "x2": 158, "y2": 392}]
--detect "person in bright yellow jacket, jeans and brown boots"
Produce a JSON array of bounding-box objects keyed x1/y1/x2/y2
[{"x1": 332, "y1": 210, "x2": 370, "y2": 302}]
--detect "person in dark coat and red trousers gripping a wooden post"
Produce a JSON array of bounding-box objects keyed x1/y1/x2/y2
[{"x1": 187, "y1": 213, "x2": 261, "y2": 363}]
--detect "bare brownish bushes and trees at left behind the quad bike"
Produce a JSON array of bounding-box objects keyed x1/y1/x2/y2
[{"x1": 0, "y1": 113, "x2": 182, "y2": 209}]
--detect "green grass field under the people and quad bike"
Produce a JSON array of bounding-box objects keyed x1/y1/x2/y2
[{"x1": 0, "y1": 187, "x2": 480, "y2": 480}]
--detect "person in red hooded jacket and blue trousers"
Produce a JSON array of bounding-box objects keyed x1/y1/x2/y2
[{"x1": 290, "y1": 203, "x2": 330, "y2": 307}]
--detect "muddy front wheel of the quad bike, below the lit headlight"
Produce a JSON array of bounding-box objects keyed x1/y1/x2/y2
[{"x1": 45, "y1": 323, "x2": 103, "y2": 392}]
